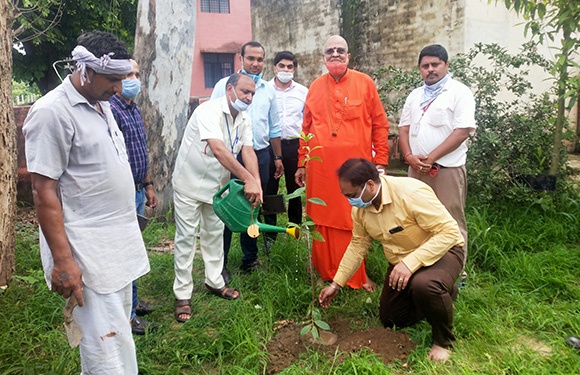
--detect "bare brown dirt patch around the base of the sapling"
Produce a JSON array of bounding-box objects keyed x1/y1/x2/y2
[{"x1": 266, "y1": 319, "x2": 416, "y2": 374}]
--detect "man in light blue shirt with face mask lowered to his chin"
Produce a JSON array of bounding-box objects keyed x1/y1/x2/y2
[{"x1": 211, "y1": 41, "x2": 284, "y2": 280}]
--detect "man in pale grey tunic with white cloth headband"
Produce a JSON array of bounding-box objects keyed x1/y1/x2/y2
[{"x1": 23, "y1": 31, "x2": 149, "y2": 374}]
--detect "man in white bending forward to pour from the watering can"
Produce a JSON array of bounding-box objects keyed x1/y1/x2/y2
[{"x1": 173, "y1": 73, "x2": 262, "y2": 322}]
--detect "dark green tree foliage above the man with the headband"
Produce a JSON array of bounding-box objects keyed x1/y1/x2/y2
[{"x1": 12, "y1": 0, "x2": 137, "y2": 94}]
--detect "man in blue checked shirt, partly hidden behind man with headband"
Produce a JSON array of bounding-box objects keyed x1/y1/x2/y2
[{"x1": 109, "y1": 59, "x2": 157, "y2": 335}]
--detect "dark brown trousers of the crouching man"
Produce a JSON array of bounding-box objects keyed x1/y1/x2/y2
[{"x1": 379, "y1": 246, "x2": 464, "y2": 348}]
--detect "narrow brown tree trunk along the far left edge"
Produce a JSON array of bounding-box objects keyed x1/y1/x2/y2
[{"x1": 0, "y1": 0, "x2": 16, "y2": 287}]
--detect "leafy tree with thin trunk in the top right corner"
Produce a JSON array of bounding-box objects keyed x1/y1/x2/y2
[{"x1": 488, "y1": 0, "x2": 580, "y2": 174}]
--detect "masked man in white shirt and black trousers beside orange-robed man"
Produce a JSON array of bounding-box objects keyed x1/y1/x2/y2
[{"x1": 265, "y1": 51, "x2": 308, "y2": 232}]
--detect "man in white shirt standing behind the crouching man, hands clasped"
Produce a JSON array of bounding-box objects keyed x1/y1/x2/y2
[{"x1": 399, "y1": 44, "x2": 477, "y2": 259}]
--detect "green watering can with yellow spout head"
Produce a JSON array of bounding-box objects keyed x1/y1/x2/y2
[{"x1": 213, "y1": 179, "x2": 300, "y2": 239}]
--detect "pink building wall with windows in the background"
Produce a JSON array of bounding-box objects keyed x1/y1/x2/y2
[{"x1": 190, "y1": 0, "x2": 252, "y2": 98}]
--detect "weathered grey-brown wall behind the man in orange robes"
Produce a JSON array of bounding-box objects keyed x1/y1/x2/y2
[{"x1": 252, "y1": 0, "x2": 465, "y2": 85}]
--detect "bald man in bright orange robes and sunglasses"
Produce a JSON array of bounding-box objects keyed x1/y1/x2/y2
[{"x1": 295, "y1": 35, "x2": 389, "y2": 291}]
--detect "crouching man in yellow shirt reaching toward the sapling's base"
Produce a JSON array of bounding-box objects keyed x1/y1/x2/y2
[{"x1": 318, "y1": 159, "x2": 463, "y2": 362}]
